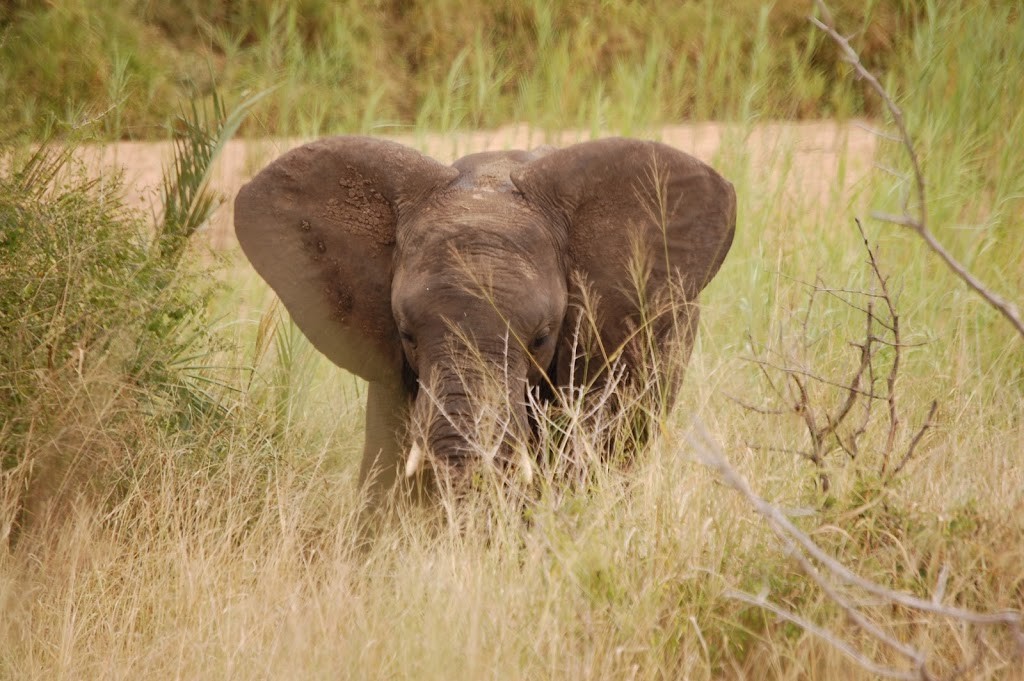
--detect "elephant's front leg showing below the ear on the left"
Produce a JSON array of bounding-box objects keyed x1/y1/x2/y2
[{"x1": 359, "y1": 381, "x2": 409, "y2": 501}]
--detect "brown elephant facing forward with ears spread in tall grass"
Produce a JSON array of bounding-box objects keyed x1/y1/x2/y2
[{"x1": 234, "y1": 137, "x2": 736, "y2": 493}]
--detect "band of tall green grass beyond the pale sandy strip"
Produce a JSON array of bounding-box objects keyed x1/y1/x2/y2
[{"x1": 0, "y1": 0, "x2": 921, "y2": 139}]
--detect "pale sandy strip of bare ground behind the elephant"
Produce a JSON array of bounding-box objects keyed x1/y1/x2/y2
[{"x1": 81, "y1": 121, "x2": 878, "y2": 249}]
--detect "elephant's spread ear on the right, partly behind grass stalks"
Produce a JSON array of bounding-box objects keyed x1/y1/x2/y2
[{"x1": 512, "y1": 138, "x2": 736, "y2": 382}]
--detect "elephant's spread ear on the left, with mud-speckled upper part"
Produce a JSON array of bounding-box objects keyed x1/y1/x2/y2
[{"x1": 234, "y1": 137, "x2": 458, "y2": 381}]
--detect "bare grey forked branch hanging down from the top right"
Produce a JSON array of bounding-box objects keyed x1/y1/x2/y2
[{"x1": 808, "y1": 0, "x2": 1024, "y2": 338}]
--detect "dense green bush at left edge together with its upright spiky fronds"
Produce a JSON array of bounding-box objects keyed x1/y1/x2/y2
[{"x1": 0, "y1": 96, "x2": 254, "y2": 541}]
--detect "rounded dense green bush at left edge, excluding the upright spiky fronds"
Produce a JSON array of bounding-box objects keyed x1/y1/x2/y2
[{"x1": 0, "y1": 146, "x2": 190, "y2": 524}]
